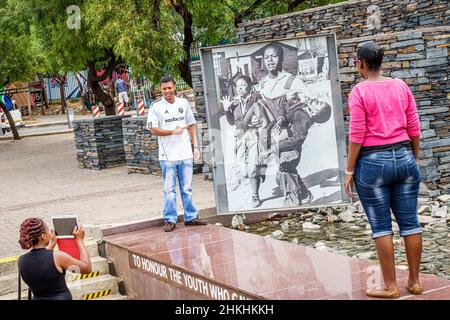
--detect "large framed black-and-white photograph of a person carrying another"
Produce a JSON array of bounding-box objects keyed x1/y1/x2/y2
[{"x1": 202, "y1": 36, "x2": 342, "y2": 212}]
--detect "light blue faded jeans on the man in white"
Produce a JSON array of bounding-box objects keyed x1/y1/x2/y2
[{"x1": 160, "y1": 159, "x2": 197, "y2": 223}]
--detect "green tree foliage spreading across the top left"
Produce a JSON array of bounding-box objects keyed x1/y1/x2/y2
[{"x1": 0, "y1": 0, "x2": 339, "y2": 86}]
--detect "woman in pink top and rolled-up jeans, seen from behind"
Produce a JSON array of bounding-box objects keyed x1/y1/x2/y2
[{"x1": 345, "y1": 42, "x2": 423, "y2": 298}]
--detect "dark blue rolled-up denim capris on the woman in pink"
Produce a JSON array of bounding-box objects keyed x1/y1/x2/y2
[{"x1": 354, "y1": 148, "x2": 422, "y2": 239}]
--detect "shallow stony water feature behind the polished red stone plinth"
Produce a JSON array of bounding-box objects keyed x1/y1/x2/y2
[{"x1": 245, "y1": 208, "x2": 450, "y2": 279}]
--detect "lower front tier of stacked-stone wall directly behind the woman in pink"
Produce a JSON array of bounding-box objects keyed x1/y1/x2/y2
[{"x1": 338, "y1": 27, "x2": 450, "y2": 195}]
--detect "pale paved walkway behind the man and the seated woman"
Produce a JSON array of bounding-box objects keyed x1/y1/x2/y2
[{"x1": 0, "y1": 133, "x2": 215, "y2": 258}]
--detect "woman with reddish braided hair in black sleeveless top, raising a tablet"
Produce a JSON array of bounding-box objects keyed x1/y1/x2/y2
[{"x1": 19, "y1": 218, "x2": 92, "y2": 300}]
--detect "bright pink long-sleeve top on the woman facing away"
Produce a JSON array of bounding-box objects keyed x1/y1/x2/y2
[{"x1": 348, "y1": 79, "x2": 420, "y2": 146}]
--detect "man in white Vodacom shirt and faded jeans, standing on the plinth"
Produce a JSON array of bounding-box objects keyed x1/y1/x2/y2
[{"x1": 147, "y1": 76, "x2": 207, "y2": 232}]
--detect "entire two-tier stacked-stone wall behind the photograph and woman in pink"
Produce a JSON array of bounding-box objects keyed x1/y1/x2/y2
[{"x1": 223, "y1": 0, "x2": 450, "y2": 195}]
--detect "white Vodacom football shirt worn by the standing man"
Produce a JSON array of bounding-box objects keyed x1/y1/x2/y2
[{"x1": 147, "y1": 97, "x2": 195, "y2": 161}]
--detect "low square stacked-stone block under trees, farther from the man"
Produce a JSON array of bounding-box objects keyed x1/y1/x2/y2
[{"x1": 73, "y1": 116, "x2": 127, "y2": 170}]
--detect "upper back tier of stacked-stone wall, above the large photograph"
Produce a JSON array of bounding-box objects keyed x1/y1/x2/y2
[{"x1": 237, "y1": 0, "x2": 450, "y2": 42}]
